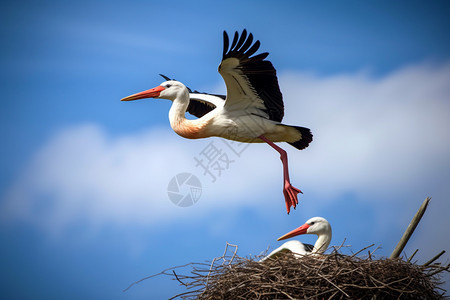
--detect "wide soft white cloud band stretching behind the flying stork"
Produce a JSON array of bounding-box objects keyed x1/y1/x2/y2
[{"x1": 1, "y1": 64, "x2": 450, "y2": 246}]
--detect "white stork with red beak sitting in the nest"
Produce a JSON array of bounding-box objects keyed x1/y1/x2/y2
[{"x1": 261, "y1": 217, "x2": 331, "y2": 261}]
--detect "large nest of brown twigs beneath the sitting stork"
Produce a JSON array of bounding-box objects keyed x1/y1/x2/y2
[{"x1": 125, "y1": 243, "x2": 449, "y2": 299}]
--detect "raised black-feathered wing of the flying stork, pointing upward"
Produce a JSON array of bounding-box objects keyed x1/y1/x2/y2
[{"x1": 219, "y1": 29, "x2": 284, "y2": 122}]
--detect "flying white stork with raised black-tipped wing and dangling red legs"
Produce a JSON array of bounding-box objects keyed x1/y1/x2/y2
[{"x1": 122, "y1": 29, "x2": 312, "y2": 214}]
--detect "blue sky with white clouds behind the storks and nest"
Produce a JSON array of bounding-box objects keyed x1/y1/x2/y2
[{"x1": 0, "y1": 1, "x2": 450, "y2": 299}]
